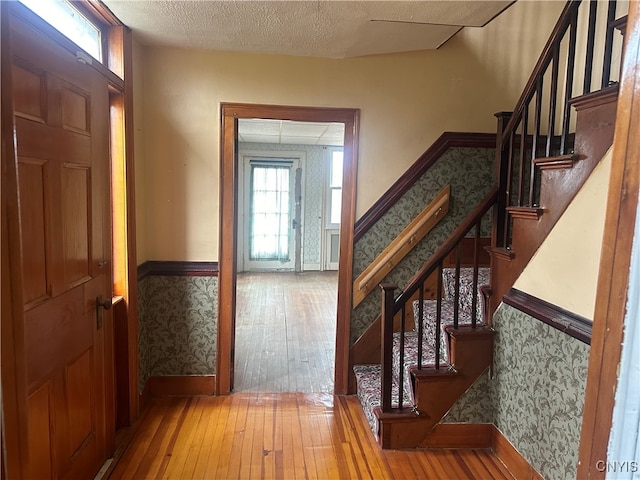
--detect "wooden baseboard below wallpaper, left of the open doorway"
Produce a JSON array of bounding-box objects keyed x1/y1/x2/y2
[{"x1": 140, "y1": 375, "x2": 216, "y2": 407}]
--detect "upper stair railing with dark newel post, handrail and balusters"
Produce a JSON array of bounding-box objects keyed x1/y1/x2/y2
[{"x1": 493, "y1": 0, "x2": 625, "y2": 250}]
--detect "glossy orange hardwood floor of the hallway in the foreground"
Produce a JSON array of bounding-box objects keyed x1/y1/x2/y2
[{"x1": 106, "y1": 393, "x2": 513, "y2": 480}]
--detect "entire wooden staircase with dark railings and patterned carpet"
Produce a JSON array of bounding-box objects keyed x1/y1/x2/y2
[{"x1": 353, "y1": 1, "x2": 626, "y2": 448}]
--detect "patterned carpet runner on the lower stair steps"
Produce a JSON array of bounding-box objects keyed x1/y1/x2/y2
[{"x1": 353, "y1": 268, "x2": 489, "y2": 439}]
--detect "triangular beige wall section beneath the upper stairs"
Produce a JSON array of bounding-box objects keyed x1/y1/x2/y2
[{"x1": 513, "y1": 146, "x2": 612, "y2": 320}]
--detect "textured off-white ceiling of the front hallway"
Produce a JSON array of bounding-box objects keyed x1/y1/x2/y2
[{"x1": 102, "y1": 0, "x2": 513, "y2": 58}]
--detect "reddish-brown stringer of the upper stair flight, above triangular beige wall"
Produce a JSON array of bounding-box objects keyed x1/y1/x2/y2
[{"x1": 489, "y1": 86, "x2": 618, "y2": 315}]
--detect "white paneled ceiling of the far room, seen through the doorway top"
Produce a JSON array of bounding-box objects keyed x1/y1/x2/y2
[{"x1": 238, "y1": 119, "x2": 344, "y2": 146}]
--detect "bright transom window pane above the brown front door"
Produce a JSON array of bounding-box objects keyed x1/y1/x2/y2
[{"x1": 20, "y1": 0, "x2": 102, "y2": 61}]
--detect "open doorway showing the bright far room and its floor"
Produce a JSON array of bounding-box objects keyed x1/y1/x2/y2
[{"x1": 233, "y1": 119, "x2": 344, "y2": 393}]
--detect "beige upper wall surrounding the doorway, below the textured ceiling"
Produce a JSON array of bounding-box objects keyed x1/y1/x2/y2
[{"x1": 135, "y1": 2, "x2": 563, "y2": 262}]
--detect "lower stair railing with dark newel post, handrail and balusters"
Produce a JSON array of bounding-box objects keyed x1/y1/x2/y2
[{"x1": 380, "y1": 187, "x2": 498, "y2": 412}]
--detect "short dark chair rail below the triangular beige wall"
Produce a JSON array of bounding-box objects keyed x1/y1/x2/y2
[{"x1": 502, "y1": 288, "x2": 593, "y2": 345}]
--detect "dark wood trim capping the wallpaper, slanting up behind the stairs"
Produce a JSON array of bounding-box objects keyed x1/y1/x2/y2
[{"x1": 353, "y1": 132, "x2": 496, "y2": 242}]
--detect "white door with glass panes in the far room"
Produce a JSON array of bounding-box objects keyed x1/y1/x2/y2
[{"x1": 244, "y1": 158, "x2": 300, "y2": 271}]
